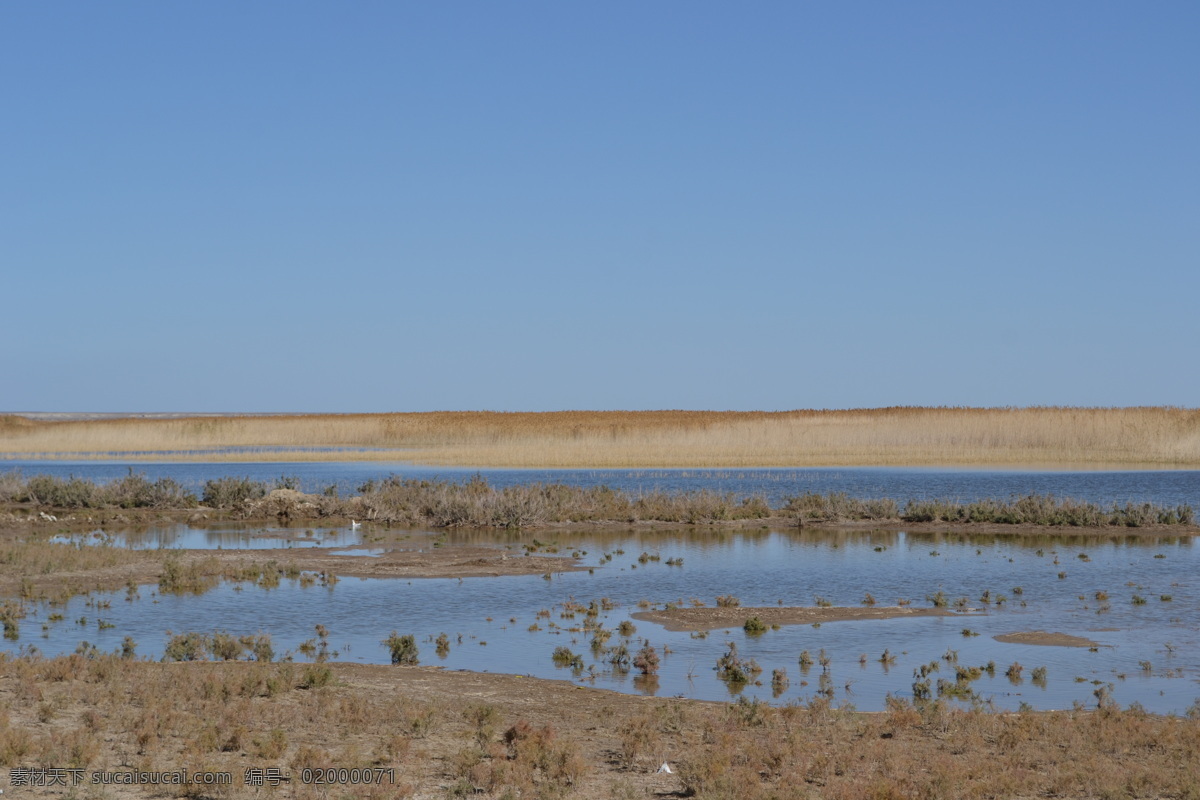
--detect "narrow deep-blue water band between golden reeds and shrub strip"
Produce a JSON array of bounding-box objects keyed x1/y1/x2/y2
[{"x1": 0, "y1": 461, "x2": 1200, "y2": 507}]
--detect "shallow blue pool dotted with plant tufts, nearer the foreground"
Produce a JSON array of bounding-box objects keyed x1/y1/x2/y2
[{"x1": 5, "y1": 522, "x2": 1200, "y2": 714}]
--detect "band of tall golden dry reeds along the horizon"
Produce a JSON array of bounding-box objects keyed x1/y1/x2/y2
[{"x1": 0, "y1": 407, "x2": 1200, "y2": 468}]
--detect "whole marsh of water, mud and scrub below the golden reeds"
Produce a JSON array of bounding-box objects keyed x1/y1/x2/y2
[{"x1": 0, "y1": 463, "x2": 1200, "y2": 798}]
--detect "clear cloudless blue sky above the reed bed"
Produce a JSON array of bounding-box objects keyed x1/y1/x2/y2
[{"x1": 0, "y1": 0, "x2": 1200, "y2": 411}]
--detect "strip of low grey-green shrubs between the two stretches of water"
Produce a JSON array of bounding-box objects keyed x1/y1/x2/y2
[{"x1": 0, "y1": 470, "x2": 1195, "y2": 528}]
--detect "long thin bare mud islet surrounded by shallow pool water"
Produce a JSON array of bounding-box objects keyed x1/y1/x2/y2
[{"x1": 632, "y1": 606, "x2": 959, "y2": 631}]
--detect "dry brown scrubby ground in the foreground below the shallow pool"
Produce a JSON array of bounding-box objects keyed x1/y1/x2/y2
[{"x1": 0, "y1": 656, "x2": 1200, "y2": 800}]
